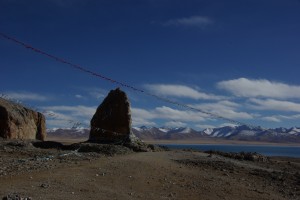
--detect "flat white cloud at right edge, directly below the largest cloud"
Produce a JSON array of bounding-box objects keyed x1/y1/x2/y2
[{"x1": 249, "y1": 98, "x2": 300, "y2": 112}]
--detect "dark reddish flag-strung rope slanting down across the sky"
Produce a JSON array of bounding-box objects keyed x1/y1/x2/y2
[{"x1": 0, "y1": 32, "x2": 257, "y2": 127}]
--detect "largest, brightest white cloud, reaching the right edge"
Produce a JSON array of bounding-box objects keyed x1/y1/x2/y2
[{"x1": 217, "y1": 78, "x2": 300, "y2": 99}]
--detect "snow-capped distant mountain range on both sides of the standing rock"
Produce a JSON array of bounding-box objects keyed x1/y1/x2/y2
[{"x1": 47, "y1": 125, "x2": 300, "y2": 143}]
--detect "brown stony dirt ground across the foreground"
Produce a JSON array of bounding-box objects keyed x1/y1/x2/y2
[{"x1": 0, "y1": 140, "x2": 300, "y2": 200}]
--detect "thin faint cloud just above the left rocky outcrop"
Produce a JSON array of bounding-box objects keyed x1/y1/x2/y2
[{"x1": 3, "y1": 92, "x2": 50, "y2": 101}]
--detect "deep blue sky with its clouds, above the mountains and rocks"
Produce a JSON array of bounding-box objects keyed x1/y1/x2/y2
[{"x1": 0, "y1": 0, "x2": 300, "y2": 130}]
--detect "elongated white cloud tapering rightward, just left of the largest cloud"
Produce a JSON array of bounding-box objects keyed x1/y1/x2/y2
[{"x1": 145, "y1": 84, "x2": 224, "y2": 100}]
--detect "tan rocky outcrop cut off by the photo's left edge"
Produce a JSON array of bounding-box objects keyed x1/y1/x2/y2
[{"x1": 0, "y1": 98, "x2": 46, "y2": 140}]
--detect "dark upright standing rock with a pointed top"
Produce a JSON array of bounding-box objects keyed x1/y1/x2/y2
[{"x1": 89, "y1": 88, "x2": 132, "y2": 143}]
